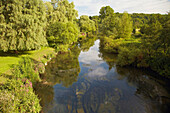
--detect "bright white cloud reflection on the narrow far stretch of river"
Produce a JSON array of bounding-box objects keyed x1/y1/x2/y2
[{"x1": 79, "y1": 40, "x2": 108, "y2": 78}]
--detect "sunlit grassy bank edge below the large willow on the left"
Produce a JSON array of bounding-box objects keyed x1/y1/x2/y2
[{"x1": 0, "y1": 47, "x2": 57, "y2": 84}]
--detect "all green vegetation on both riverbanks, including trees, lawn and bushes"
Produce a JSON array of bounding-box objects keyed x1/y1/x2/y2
[{"x1": 0, "y1": 0, "x2": 170, "y2": 113}]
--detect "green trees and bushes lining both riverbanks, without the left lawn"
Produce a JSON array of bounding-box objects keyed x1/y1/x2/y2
[{"x1": 0, "y1": 0, "x2": 170, "y2": 75}]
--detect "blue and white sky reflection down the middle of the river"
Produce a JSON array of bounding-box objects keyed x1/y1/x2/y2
[{"x1": 38, "y1": 40, "x2": 170, "y2": 113}]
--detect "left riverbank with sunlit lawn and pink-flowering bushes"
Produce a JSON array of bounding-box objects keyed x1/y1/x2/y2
[{"x1": 0, "y1": 47, "x2": 56, "y2": 112}]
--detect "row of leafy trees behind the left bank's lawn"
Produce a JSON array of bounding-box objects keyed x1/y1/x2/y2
[{"x1": 0, "y1": 0, "x2": 95, "y2": 52}]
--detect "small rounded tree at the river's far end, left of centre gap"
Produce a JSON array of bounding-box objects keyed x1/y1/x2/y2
[{"x1": 80, "y1": 15, "x2": 96, "y2": 32}]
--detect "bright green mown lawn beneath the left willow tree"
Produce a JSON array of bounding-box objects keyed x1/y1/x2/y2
[{"x1": 0, "y1": 47, "x2": 55, "y2": 74}]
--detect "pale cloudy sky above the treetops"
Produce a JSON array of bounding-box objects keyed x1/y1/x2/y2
[{"x1": 43, "y1": 0, "x2": 170, "y2": 16}]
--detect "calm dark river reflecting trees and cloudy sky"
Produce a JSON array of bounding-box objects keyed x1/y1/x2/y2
[{"x1": 36, "y1": 39, "x2": 170, "y2": 113}]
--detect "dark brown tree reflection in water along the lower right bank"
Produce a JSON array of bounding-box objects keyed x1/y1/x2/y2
[{"x1": 117, "y1": 66, "x2": 170, "y2": 113}]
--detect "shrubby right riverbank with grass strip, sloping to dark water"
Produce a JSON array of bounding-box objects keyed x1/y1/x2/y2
[{"x1": 100, "y1": 34, "x2": 170, "y2": 79}]
